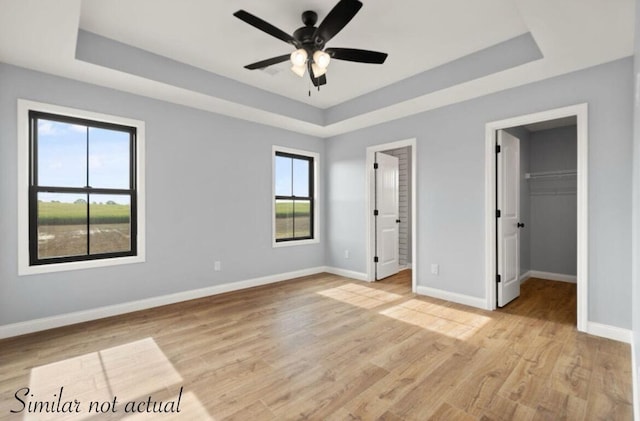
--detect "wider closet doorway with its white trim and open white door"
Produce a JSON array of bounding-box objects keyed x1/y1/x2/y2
[{"x1": 485, "y1": 104, "x2": 588, "y2": 331}]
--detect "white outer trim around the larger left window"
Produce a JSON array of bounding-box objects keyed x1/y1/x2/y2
[{"x1": 17, "y1": 99, "x2": 146, "y2": 276}]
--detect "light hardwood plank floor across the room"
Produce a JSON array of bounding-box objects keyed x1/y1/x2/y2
[{"x1": 0, "y1": 271, "x2": 632, "y2": 421}]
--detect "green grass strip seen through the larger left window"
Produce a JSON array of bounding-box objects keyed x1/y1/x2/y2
[{"x1": 38, "y1": 202, "x2": 131, "y2": 225}]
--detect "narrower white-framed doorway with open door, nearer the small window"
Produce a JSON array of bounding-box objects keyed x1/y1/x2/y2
[{"x1": 366, "y1": 139, "x2": 416, "y2": 292}]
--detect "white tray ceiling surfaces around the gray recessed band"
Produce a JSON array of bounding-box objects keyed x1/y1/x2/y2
[{"x1": 0, "y1": 0, "x2": 634, "y2": 136}]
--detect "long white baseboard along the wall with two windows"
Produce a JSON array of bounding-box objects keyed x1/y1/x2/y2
[{"x1": 0, "y1": 266, "x2": 327, "y2": 339}]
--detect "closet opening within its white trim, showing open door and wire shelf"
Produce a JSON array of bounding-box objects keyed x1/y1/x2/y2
[{"x1": 496, "y1": 116, "x2": 577, "y2": 307}]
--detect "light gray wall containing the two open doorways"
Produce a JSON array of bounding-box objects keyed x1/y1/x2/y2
[{"x1": 325, "y1": 59, "x2": 633, "y2": 328}]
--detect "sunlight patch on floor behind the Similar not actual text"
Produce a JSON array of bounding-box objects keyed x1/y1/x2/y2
[{"x1": 17, "y1": 338, "x2": 212, "y2": 421}]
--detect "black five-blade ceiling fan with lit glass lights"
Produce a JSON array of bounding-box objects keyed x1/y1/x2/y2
[{"x1": 233, "y1": 0, "x2": 387, "y2": 89}]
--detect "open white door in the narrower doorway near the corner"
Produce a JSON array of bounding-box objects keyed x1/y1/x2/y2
[{"x1": 375, "y1": 152, "x2": 400, "y2": 279}]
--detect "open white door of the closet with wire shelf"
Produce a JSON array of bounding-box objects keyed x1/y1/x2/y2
[{"x1": 497, "y1": 130, "x2": 520, "y2": 307}]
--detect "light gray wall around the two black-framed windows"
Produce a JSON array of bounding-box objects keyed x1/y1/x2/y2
[{"x1": 0, "y1": 64, "x2": 325, "y2": 325}]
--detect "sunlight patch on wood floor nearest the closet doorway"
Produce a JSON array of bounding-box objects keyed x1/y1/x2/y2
[{"x1": 380, "y1": 299, "x2": 491, "y2": 340}]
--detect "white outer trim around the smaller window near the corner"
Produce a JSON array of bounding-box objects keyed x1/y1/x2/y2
[{"x1": 271, "y1": 145, "x2": 320, "y2": 248}]
